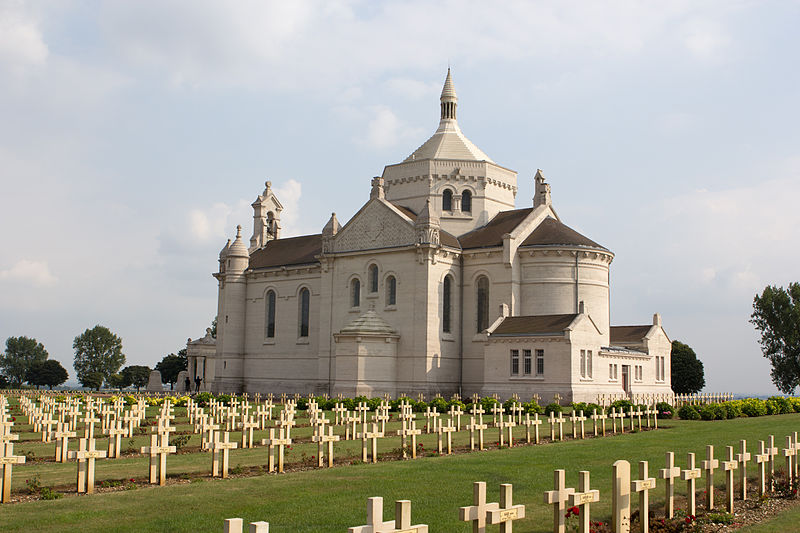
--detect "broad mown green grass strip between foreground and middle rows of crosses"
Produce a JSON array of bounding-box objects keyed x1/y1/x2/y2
[{"x1": 0, "y1": 414, "x2": 800, "y2": 533}]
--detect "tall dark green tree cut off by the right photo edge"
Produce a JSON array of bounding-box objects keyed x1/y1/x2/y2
[{"x1": 750, "y1": 282, "x2": 800, "y2": 394}]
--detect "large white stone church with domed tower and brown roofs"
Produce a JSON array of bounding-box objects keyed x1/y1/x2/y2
[{"x1": 187, "y1": 70, "x2": 671, "y2": 401}]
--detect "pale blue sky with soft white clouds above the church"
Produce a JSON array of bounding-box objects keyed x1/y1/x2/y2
[{"x1": 0, "y1": 0, "x2": 800, "y2": 394}]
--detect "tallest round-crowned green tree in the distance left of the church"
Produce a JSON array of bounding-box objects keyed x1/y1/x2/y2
[{"x1": 72, "y1": 324, "x2": 125, "y2": 389}]
